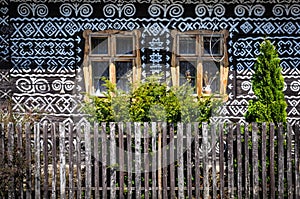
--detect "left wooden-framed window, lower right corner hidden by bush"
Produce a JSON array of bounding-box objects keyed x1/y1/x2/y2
[{"x1": 84, "y1": 30, "x2": 141, "y2": 96}]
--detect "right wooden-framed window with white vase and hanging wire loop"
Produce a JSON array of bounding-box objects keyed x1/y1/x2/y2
[{"x1": 171, "y1": 30, "x2": 228, "y2": 96}]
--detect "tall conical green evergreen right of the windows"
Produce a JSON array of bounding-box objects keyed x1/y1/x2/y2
[{"x1": 245, "y1": 40, "x2": 287, "y2": 123}]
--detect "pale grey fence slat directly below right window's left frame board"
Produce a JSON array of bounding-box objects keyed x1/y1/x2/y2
[{"x1": 177, "y1": 123, "x2": 185, "y2": 199}]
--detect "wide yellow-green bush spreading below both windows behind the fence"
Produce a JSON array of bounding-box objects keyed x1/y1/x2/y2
[{"x1": 84, "y1": 76, "x2": 220, "y2": 123}]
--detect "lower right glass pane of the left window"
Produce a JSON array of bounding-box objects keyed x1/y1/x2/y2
[{"x1": 115, "y1": 61, "x2": 132, "y2": 92}]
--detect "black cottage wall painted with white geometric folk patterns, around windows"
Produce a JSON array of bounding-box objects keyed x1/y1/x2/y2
[{"x1": 0, "y1": 0, "x2": 300, "y2": 122}]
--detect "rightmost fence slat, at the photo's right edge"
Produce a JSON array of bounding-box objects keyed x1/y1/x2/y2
[{"x1": 294, "y1": 124, "x2": 300, "y2": 198}]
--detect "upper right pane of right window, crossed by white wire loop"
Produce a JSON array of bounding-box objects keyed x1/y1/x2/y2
[{"x1": 203, "y1": 37, "x2": 221, "y2": 55}]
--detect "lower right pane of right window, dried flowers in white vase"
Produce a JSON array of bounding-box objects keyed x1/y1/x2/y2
[{"x1": 203, "y1": 61, "x2": 220, "y2": 93}]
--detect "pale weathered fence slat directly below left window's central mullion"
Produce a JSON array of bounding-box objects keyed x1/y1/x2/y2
[{"x1": 109, "y1": 122, "x2": 118, "y2": 198}]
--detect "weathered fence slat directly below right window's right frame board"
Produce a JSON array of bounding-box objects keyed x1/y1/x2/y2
[{"x1": 219, "y1": 123, "x2": 225, "y2": 198}]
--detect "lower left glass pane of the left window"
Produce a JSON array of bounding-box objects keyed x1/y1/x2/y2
[{"x1": 92, "y1": 61, "x2": 109, "y2": 94}]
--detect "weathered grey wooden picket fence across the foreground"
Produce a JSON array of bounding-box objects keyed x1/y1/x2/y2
[{"x1": 0, "y1": 122, "x2": 300, "y2": 199}]
